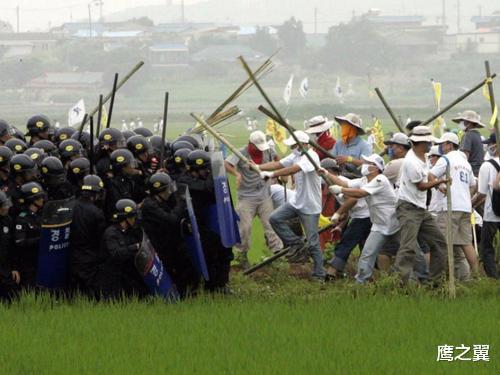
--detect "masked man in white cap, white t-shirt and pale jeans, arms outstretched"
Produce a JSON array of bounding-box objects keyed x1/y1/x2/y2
[{"x1": 324, "y1": 154, "x2": 399, "y2": 283}]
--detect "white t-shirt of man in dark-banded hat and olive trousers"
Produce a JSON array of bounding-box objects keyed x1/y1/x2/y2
[{"x1": 399, "y1": 150, "x2": 429, "y2": 210}]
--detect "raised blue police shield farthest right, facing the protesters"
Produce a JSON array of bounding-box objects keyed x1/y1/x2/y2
[{"x1": 208, "y1": 152, "x2": 241, "y2": 247}]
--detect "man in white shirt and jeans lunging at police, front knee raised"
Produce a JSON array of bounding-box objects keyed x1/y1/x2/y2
[{"x1": 259, "y1": 130, "x2": 325, "y2": 280}]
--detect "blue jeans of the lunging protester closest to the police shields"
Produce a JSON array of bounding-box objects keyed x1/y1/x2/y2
[{"x1": 269, "y1": 203, "x2": 326, "y2": 278}]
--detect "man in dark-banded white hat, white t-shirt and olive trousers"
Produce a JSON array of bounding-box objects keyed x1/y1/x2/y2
[{"x1": 394, "y1": 126, "x2": 447, "y2": 283}]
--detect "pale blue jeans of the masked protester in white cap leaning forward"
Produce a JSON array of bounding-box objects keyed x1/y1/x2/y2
[{"x1": 355, "y1": 231, "x2": 399, "y2": 283}]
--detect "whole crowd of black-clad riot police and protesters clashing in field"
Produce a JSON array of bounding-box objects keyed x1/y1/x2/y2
[{"x1": 0, "y1": 111, "x2": 500, "y2": 299}]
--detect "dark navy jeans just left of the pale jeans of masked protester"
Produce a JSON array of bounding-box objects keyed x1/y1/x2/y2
[{"x1": 330, "y1": 217, "x2": 372, "y2": 271}]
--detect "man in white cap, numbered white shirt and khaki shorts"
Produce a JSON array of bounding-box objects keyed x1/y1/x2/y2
[{"x1": 430, "y1": 133, "x2": 478, "y2": 280}]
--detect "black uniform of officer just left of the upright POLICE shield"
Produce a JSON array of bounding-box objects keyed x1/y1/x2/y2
[{"x1": 14, "y1": 208, "x2": 42, "y2": 288}]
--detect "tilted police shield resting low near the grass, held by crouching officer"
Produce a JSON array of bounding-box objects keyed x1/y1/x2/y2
[{"x1": 134, "y1": 232, "x2": 179, "y2": 300}]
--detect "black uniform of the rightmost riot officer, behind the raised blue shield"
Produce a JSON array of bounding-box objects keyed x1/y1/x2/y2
[{"x1": 178, "y1": 174, "x2": 234, "y2": 291}]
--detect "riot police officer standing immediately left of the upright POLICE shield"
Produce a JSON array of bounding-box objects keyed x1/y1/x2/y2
[{"x1": 14, "y1": 182, "x2": 45, "y2": 288}]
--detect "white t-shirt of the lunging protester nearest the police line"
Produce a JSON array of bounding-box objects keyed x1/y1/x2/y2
[{"x1": 280, "y1": 149, "x2": 321, "y2": 215}]
